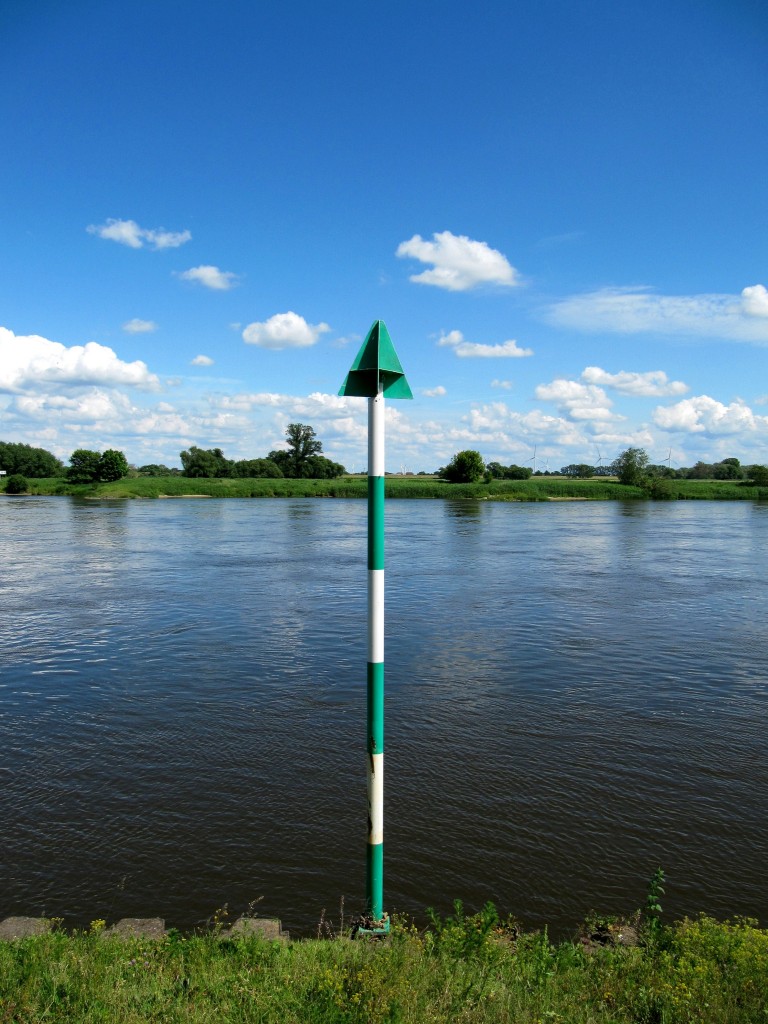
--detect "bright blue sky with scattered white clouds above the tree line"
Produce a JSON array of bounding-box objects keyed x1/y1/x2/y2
[{"x1": 0, "y1": 0, "x2": 768, "y2": 471}]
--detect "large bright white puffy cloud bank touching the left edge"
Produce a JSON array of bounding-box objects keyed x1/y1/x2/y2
[{"x1": 0, "y1": 328, "x2": 160, "y2": 393}]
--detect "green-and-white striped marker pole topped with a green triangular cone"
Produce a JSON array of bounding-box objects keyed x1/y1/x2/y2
[{"x1": 339, "y1": 321, "x2": 413, "y2": 935}]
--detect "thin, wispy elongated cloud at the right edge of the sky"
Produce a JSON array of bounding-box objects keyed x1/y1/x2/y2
[{"x1": 545, "y1": 285, "x2": 768, "y2": 344}]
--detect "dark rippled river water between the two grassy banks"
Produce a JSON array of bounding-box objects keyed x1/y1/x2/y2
[{"x1": 0, "y1": 498, "x2": 768, "y2": 934}]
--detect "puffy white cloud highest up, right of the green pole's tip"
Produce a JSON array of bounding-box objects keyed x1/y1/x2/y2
[{"x1": 396, "y1": 231, "x2": 520, "y2": 292}]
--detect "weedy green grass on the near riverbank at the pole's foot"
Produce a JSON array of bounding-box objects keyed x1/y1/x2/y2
[{"x1": 0, "y1": 904, "x2": 768, "y2": 1024}]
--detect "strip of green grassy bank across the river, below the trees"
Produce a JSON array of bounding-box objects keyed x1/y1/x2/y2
[{"x1": 2, "y1": 476, "x2": 768, "y2": 502}]
